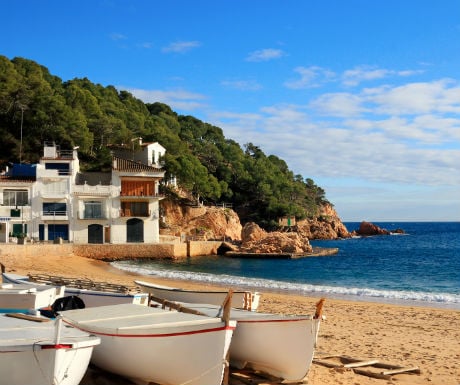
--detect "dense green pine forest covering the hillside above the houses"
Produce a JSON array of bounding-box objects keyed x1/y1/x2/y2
[{"x1": 0, "y1": 56, "x2": 328, "y2": 229}]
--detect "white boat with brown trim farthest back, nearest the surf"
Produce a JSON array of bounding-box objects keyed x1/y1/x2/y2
[{"x1": 134, "y1": 280, "x2": 260, "y2": 311}]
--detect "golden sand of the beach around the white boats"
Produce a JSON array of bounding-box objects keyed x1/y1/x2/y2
[{"x1": 0, "y1": 255, "x2": 460, "y2": 385}]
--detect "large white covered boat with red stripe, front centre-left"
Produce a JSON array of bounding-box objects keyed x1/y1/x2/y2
[{"x1": 61, "y1": 304, "x2": 236, "y2": 385}]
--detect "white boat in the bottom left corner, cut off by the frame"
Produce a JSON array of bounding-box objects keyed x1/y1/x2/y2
[{"x1": 0, "y1": 314, "x2": 100, "y2": 385}]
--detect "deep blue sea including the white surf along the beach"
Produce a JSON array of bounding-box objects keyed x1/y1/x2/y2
[{"x1": 113, "y1": 222, "x2": 460, "y2": 309}]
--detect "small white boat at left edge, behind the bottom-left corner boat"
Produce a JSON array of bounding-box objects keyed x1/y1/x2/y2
[{"x1": 0, "y1": 283, "x2": 64, "y2": 313}]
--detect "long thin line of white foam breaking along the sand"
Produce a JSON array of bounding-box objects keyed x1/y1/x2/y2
[{"x1": 111, "y1": 261, "x2": 460, "y2": 307}]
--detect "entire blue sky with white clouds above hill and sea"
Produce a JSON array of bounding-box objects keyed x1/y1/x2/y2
[{"x1": 0, "y1": 0, "x2": 460, "y2": 221}]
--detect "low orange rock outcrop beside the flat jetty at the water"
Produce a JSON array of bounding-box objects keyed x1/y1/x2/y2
[{"x1": 240, "y1": 222, "x2": 313, "y2": 254}]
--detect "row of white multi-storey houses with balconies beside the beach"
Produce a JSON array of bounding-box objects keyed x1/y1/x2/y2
[{"x1": 0, "y1": 143, "x2": 165, "y2": 243}]
